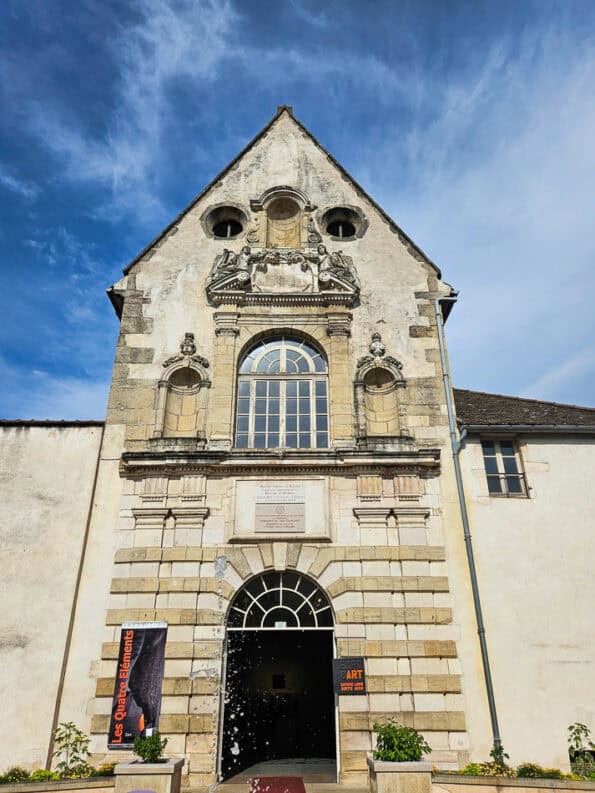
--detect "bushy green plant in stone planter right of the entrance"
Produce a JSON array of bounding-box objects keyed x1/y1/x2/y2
[{"x1": 367, "y1": 719, "x2": 432, "y2": 793}]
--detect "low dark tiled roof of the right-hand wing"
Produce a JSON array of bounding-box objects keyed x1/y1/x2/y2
[{"x1": 454, "y1": 388, "x2": 595, "y2": 427}]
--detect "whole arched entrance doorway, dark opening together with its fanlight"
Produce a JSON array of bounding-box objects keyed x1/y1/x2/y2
[{"x1": 219, "y1": 570, "x2": 336, "y2": 781}]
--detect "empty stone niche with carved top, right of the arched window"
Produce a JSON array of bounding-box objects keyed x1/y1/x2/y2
[{"x1": 354, "y1": 333, "x2": 405, "y2": 442}]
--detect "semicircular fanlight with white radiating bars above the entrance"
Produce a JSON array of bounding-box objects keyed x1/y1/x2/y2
[{"x1": 227, "y1": 570, "x2": 333, "y2": 628}]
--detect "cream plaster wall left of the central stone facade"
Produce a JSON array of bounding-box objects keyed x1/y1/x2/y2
[{"x1": 0, "y1": 426, "x2": 102, "y2": 769}]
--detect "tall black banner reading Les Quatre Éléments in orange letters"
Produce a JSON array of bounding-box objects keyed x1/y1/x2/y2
[{"x1": 107, "y1": 625, "x2": 167, "y2": 749}]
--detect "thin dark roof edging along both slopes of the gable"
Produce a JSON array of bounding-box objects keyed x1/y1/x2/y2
[{"x1": 123, "y1": 105, "x2": 441, "y2": 278}]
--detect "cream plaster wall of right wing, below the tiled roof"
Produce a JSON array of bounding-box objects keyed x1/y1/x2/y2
[{"x1": 461, "y1": 436, "x2": 595, "y2": 768}]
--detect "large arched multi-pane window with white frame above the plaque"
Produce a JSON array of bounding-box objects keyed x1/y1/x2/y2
[{"x1": 236, "y1": 337, "x2": 328, "y2": 449}]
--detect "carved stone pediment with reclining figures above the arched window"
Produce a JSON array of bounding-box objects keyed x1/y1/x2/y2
[{"x1": 207, "y1": 244, "x2": 360, "y2": 305}]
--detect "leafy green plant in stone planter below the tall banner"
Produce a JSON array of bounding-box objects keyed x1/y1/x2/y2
[{"x1": 114, "y1": 732, "x2": 184, "y2": 793}]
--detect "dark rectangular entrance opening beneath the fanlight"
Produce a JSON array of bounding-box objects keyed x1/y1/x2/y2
[{"x1": 221, "y1": 629, "x2": 336, "y2": 779}]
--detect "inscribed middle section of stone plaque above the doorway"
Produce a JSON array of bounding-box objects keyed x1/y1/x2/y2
[{"x1": 254, "y1": 482, "x2": 306, "y2": 534}]
